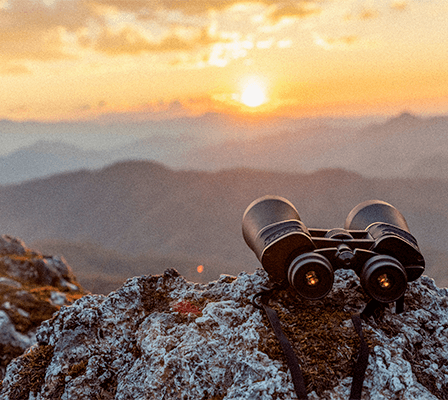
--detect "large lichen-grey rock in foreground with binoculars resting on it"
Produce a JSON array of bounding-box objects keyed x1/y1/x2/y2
[{"x1": 0, "y1": 260, "x2": 448, "y2": 400}]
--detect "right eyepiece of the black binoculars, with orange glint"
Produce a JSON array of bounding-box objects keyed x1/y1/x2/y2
[{"x1": 360, "y1": 255, "x2": 407, "y2": 303}]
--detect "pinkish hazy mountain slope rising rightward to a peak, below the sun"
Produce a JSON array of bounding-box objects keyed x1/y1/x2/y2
[{"x1": 186, "y1": 113, "x2": 448, "y2": 179}]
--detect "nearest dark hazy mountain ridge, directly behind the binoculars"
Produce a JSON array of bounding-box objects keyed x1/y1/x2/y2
[{"x1": 0, "y1": 161, "x2": 448, "y2": 291}]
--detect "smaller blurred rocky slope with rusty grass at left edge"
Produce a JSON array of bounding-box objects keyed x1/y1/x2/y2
[{"x1": 0, "y1": 235, "x2": 85, "y2": 380}]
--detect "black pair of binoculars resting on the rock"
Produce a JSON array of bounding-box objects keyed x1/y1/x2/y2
[{"x1": 243, "y1": 196, "x2": 425, "y2": 303}]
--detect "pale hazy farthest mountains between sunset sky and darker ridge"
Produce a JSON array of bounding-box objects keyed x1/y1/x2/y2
[{"x1": 0, "y1": 113, "x2": 448, "y2": 184}]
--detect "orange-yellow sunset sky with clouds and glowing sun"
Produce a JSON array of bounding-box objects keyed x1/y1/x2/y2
[{"x1": 0, "y1": 0, "x2": 448, "y2": 121}]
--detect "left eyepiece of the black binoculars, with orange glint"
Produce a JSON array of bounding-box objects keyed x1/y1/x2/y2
[{"x1": 288, "y1": 253, "x2": 334, "y2": 300}]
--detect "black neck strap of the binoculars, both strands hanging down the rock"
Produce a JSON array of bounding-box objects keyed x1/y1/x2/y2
[{"x1": 252, "y1": 290, "x2": 369, "y2": 400}]
